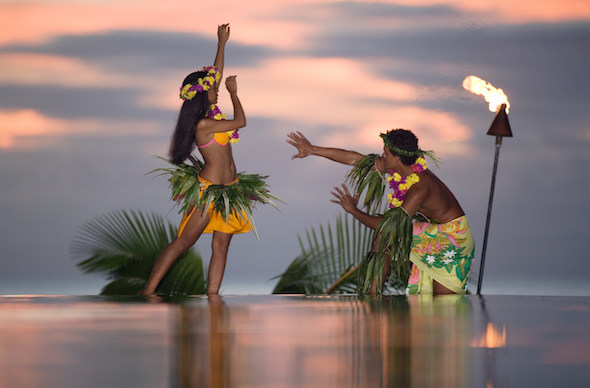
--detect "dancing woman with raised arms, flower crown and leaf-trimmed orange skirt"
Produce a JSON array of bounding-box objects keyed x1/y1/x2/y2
[{"x1": 141, "y1": 24, "x2": 280, "y2": 295}]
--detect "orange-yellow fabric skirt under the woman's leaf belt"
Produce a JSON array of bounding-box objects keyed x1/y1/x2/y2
[{"x1": 178, "y1": 177, "x2": 252, "y2": 237}]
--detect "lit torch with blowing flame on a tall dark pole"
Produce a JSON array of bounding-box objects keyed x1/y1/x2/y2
[{"x1": 463, "y1": 75, "x2": 512, "y2": 295}]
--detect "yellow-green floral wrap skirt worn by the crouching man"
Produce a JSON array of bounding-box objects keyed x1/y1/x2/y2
[{"x1": 408, "y1": 216, "x2": 475, "y2": 294}]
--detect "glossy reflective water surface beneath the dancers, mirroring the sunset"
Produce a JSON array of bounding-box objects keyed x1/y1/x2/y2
[{"x1": 0, "y1": 295, "x2": 590, "y2": 388}]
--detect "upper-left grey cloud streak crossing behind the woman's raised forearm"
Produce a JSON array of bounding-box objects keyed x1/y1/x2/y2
[{"x1": 0, "y1": 29, "x2": 269, "y2": 75}]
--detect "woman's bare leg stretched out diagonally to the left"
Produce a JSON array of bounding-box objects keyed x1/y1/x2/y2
[{"x1": 140, "y1": 210, "x2": 209, "y2": 295}]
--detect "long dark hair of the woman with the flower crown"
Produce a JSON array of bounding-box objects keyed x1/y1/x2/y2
[{"x1": 169, "y1": 71, "x2": 211, "y2": 164}]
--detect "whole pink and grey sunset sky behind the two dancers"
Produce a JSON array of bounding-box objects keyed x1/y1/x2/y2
[{"x1": 0, "y1": 0, "x2": 590, "y2": 295}]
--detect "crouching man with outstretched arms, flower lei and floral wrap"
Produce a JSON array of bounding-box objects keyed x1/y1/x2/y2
[{"x1": 287, "y1": 129, "x2": 474, "y2": 294}]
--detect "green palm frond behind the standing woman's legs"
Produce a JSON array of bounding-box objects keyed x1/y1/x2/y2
[{"x1": 71, "y1": 210, "x2": 206, "y2": 295}]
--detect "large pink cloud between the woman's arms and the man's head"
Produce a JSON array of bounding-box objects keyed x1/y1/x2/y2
[{"x1": 209, "y1": 57, "x2": 471, "y2": 154}]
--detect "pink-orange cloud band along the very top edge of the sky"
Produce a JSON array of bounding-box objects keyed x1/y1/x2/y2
[{"x1": 0, "y1": 0, "x2": 590, "y2": 48}]
